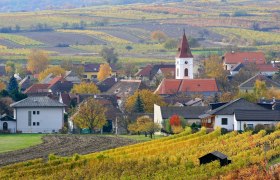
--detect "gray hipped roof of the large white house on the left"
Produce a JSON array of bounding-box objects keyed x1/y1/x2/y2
[{"x1": 10, "y1": 96, "x2": 66, "y2": 108}]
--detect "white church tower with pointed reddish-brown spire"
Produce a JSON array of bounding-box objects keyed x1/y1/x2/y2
[{"x1": 175, "y1": 30, "x2": 193, "y2": 79}]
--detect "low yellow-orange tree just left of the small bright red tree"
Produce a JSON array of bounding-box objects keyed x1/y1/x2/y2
[{"x1": 128, "y1": 116, "x2": 160, "y2": 138}]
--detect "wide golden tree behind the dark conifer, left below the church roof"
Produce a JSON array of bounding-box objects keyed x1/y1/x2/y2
[{"x1": 125, "y1": 89, "x2": 166, "y2": 113}]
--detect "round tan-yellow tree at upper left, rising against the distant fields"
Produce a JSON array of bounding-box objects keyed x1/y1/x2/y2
[{"x1": 27, "y1": 50, "x2": 49, "y2": 73}]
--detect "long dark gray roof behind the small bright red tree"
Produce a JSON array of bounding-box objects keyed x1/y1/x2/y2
[{"x1": 161, "y1": 106, "x2": 209, "y2": 119}]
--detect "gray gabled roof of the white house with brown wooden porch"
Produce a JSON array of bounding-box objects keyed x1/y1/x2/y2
[{"x1": 199, "y1": 98, "x2": 266, "y2": 118}]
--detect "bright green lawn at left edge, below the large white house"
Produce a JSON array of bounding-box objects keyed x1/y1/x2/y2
[{"x1": 0, "y1": 134, "x2": 43, "y2": 153}]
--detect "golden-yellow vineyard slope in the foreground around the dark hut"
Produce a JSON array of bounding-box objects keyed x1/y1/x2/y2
[{"x1": 0, "y1": 128, "x2": 280, "y2": 179}]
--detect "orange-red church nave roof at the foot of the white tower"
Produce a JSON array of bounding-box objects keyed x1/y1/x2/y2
[{"x1": 156, "y1": 79, "x2": 219, "y2": 94}]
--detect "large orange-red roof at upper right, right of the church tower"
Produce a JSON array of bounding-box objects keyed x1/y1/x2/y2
[{"x1": 224, "y1": 52, "x2": 266, "y2": 64}]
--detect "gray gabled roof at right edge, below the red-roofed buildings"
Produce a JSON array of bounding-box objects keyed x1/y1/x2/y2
[{"x1": 239, "y1": 74, "x2": 280, "y2": 89}]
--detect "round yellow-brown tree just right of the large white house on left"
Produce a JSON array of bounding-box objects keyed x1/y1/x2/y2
[{"x1": 73, "y1": 98, "x2": 107, "y2": 132}]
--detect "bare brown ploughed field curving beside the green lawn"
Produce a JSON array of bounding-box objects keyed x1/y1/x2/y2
[{"x1": 0, "y1": 135, "x2": 136, "y2": 166}]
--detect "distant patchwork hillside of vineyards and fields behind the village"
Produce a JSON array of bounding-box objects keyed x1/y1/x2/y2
[{"x1": 0, "y1": 0, "x2": 280, "y2": 64}]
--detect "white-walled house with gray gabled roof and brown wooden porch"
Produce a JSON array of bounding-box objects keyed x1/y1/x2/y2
[{"x1": 199, "y1": 98, "x2": 267, "y2": 131}]
